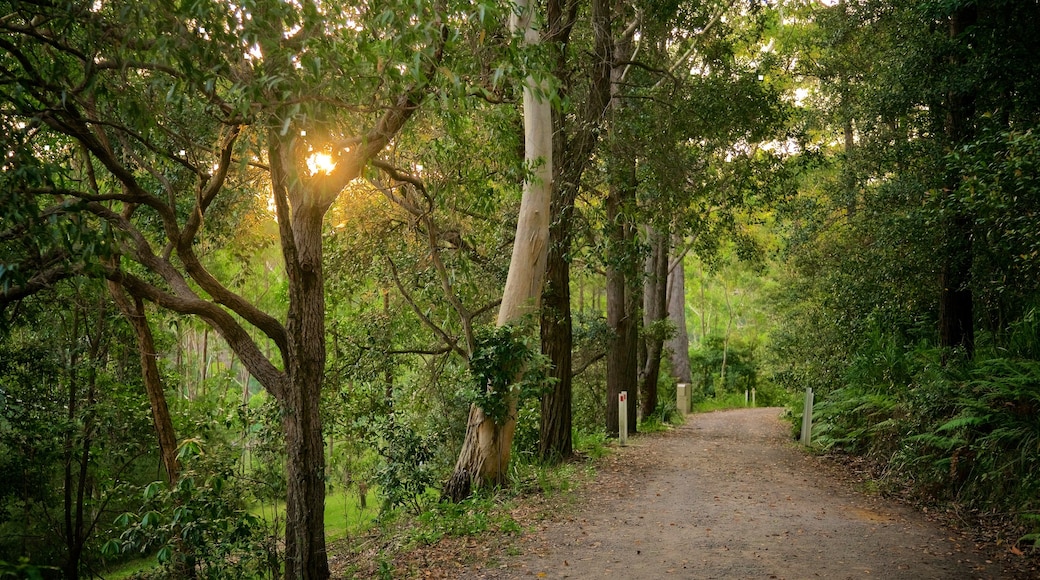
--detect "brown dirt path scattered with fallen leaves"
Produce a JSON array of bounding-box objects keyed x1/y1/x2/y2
[{"x1": 461, "y1": 408, "x2": 1031, "y2": 579}]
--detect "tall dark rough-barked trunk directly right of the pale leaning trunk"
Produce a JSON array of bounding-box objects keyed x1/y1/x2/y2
[{"x1": 539, "y1": 0, "x2": 610, "y2": 460}]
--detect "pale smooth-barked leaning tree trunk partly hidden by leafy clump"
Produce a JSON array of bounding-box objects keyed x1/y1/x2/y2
[{"x1": 444, "y1": 0, "x2": 552, "y2": 501}]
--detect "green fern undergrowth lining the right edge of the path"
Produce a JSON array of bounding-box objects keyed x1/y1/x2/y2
[{"x1": 813, "y1": 315, "x2": 1040, "y2": 540}]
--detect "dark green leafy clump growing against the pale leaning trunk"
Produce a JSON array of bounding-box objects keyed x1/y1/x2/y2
[{"x1": 459, "y1": 324, "x2": 548, "y2": 425}]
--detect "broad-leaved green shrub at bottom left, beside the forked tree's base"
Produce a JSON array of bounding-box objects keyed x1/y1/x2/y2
[{"x1": 109, "y1": 440, "x2": 280, "y2": 580}]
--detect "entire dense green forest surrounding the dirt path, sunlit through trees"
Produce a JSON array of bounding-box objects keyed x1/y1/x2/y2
[{"x1": 0, "y1": 0, "x2": 1040, "y2": 578}]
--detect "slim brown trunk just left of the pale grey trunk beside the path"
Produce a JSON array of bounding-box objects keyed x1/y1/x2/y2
[{"x1": 640, "y1": 226, "x2": 671, "y2": 417}]
